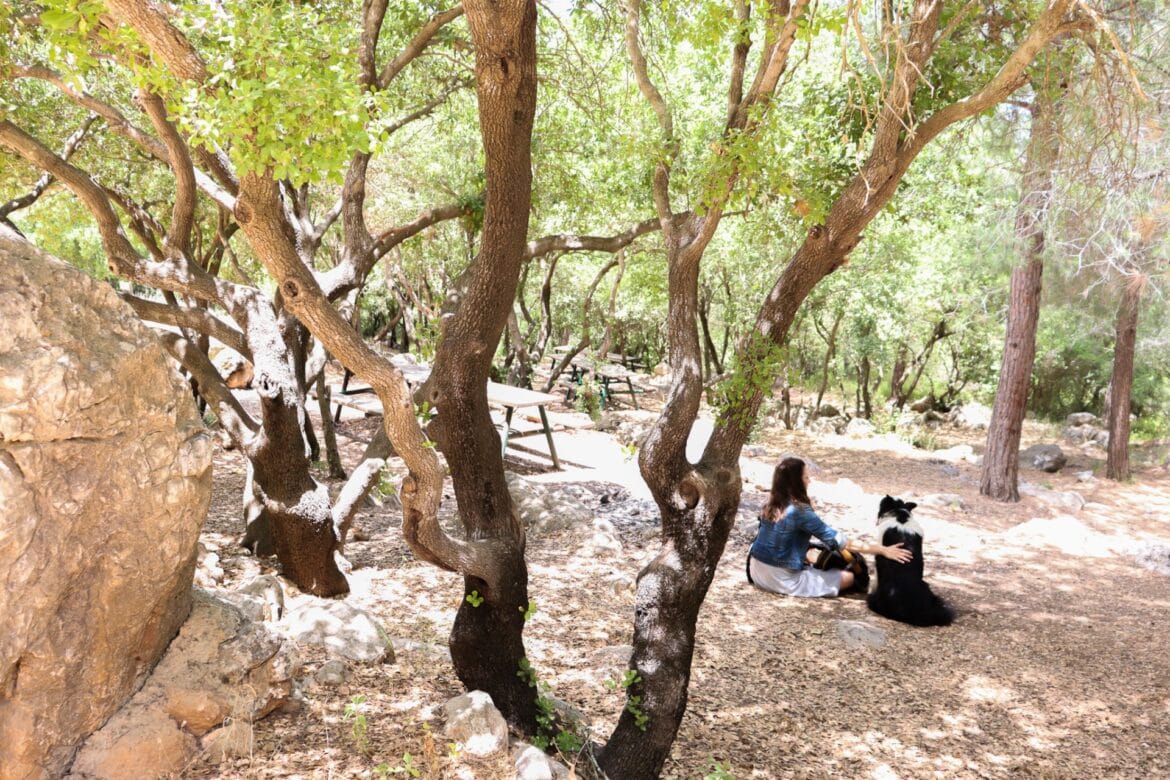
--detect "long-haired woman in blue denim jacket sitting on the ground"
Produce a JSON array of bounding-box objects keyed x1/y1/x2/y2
[{"x1": 748, "y1": 457, "x2": 914, "y2": 598}]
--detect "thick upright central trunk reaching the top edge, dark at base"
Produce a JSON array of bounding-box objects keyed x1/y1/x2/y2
[{"x1": 422, "y1": 0, "x2": 538, "y2": 733}]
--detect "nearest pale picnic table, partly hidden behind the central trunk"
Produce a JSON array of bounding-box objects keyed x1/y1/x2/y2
[{"x1": 331, "y1": 364, "x2": 560, "y2": 469}]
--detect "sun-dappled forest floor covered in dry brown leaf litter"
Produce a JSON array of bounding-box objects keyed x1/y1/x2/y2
[{"x1": 177, "y1": 378, "x2": 1170, "y2": 780}]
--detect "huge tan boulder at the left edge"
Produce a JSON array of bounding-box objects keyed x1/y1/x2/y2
[{"x1": 0, "y1": 236, "x2": 212, "y2": 780}]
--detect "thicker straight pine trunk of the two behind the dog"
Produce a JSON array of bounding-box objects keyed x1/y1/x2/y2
[{"x1": 979, "y1": 97, "x2": 1060, "y2": 502}]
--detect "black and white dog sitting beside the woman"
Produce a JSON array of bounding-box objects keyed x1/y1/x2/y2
[{"x1": 866, "y1": 496, "x2": 955, "y2": 626}]
